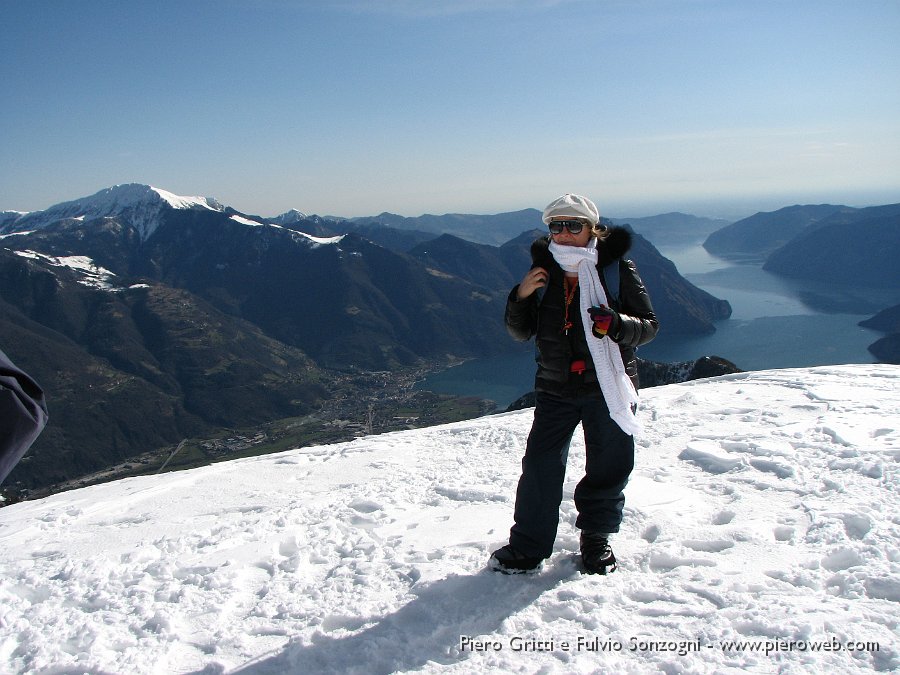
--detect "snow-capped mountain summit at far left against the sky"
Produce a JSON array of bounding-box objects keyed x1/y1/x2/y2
[{"x1": 0, "y1": 183, "x2": 224, "y2": 239}]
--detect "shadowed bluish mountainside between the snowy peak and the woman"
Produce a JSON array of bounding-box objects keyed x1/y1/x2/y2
[{"x1": 136, "y1": 213, "x2": 504, "y2": 370}]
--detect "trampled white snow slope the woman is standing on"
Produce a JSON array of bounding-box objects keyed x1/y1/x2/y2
[{"x1": 0, "y1": 365, "x2": 900, "y2": 673}]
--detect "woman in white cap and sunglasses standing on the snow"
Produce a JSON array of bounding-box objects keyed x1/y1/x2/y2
[{"x1": 490, "y1": 194, "x2": 659, "y2": 574}]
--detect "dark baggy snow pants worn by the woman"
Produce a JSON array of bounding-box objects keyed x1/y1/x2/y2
[{"x1": 509, "y1": 390, "x2": 634, "y2": 558}]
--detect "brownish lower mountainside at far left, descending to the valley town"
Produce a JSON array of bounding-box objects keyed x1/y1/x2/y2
[{"x1": 0, "y1": 249, "x2": 328, "y2": 489}]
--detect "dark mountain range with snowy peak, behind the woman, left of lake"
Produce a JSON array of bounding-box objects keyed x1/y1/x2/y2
[{"x1": 0, "y1": 184, "x2": 730, "y2": 487}]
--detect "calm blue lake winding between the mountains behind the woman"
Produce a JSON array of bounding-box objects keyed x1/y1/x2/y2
[{"x1": 417, "y1": 243, "x2": 900, "y2": 410}]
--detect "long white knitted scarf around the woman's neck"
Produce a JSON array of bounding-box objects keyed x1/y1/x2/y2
[{"x1": 550, "y1": 237, "x2": 641, "y2": 436}]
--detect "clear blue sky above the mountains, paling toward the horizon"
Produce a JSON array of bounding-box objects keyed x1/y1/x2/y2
[{"x1": 0, "y1": 0, "x2": 900, "y2": 217}]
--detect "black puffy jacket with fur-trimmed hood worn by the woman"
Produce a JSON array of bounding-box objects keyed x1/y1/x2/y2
[{"x1": 505, "y1": 227, "x2": 659, "y2": 396}]
